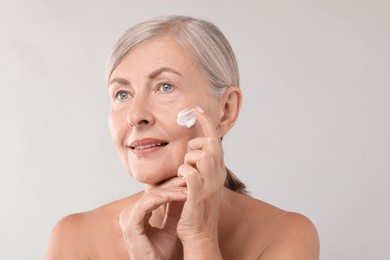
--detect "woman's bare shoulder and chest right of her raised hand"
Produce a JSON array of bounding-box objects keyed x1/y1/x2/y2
[{"x1": 226, "y1": 190, "x2": 319, "y2": 260}]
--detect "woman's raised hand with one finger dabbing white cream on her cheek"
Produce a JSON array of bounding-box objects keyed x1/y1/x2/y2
[{"x1": 177, "y1": 106, "x2": 226, "y2": 253}]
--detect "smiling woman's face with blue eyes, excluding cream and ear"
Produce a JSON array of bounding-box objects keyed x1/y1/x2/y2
[{"x1": 108, "y1": 38, "x2": 220, "y2": 185}]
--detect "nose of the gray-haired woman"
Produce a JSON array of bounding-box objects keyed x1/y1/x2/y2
[{"x1": 127, "y1": 97, "x2": 154, "y2": 127}]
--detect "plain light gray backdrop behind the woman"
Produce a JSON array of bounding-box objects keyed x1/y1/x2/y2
[{"x1": 0, "y1": 0, "x2": 390, "y2": 260}]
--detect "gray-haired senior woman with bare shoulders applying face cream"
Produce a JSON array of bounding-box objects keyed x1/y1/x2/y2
[{"x1": 47, "y1": 16, "x2": 319, "y2": 260}]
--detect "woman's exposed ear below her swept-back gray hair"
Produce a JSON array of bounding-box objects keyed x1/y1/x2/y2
[{"x1": 217, "y1": 86, "x2": 242, "y2": 137}]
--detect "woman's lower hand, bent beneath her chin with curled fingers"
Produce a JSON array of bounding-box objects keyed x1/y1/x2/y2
[{"x1": 119, "y1": 177, "x2": 187, "y2": 260}]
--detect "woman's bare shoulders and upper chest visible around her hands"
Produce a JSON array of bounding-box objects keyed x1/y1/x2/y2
[{"x1": 48, "y1": 189, "x2": 319, "y2": 260}]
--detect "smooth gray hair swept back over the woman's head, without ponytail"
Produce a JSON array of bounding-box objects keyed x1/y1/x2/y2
[{"x1": 106, "y1": 16, "x2": 239, "y2": 96}]
